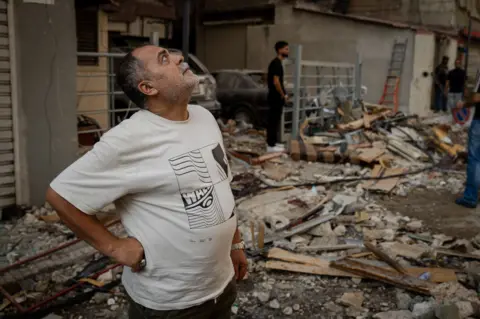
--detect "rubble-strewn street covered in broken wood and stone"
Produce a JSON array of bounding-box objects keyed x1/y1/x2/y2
[{"x1": 0, "y1": 105, "x2": 480, "y2": 319}]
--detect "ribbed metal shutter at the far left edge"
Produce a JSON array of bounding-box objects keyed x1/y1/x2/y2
[{"x1": 0, "y1": 0, "x2": 15, "y2": 208}]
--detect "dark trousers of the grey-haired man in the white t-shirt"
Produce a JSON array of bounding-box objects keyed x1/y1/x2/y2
[{"x1": 128, "y1": 280, "x2": 237, "y2": 319}]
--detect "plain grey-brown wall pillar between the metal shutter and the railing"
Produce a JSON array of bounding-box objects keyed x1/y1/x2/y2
[{"x1": 13, "y1": 0, "x2": 77, "y2": 205}]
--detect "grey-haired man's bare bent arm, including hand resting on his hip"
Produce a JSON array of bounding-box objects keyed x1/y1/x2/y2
[{"x1": 47, "y1": 188, "x2": 144, "y2": 270}]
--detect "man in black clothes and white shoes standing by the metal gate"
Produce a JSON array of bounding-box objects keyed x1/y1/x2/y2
[{"x1": 267, "y1": 41, "x2": 288, "y2": 152}]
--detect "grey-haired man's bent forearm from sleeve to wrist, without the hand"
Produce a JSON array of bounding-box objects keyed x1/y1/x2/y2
[{"x1": 47, "y1": 188, "x2": 118, "y2": 257}]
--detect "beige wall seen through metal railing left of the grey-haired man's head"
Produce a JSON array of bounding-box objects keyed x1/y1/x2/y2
[{"x1": 77, "y1": 11, "x2": 109, "y2": 128}]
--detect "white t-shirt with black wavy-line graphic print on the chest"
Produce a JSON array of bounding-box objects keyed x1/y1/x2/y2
[{"x1": 50, "y1": 105, "x2": 237, "y2": 310}]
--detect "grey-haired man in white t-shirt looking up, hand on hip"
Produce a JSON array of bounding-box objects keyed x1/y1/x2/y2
[{"x1": 47, "y1": 46, "x2": 247, "y2": 319}]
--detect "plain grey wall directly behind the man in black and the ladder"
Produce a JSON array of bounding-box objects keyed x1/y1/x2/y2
[{"x1": 246, "y1": 6, "x2": 415, "y2": 111}]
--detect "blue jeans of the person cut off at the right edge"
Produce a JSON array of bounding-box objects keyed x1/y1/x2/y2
[{"x1": 463, "y1": 119, "x2": 480, "y2": 204}]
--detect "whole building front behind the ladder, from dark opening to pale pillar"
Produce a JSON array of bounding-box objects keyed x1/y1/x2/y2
[{"x1": 197, "y1": 0, "x2": 458, "y2": 115}]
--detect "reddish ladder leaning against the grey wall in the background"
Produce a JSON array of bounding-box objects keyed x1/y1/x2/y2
[{"x1": 378, "y1": 39, "x2": 408, "y2": 113}]
